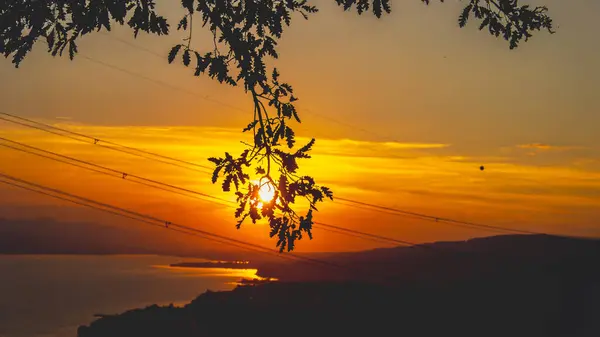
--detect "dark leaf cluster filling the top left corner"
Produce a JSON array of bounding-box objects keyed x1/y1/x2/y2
[{"x1": 0, "y1": 0, "x2": 169, "y2": 67}]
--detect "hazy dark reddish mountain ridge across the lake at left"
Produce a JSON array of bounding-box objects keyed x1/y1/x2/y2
[{"x1": 0, "y1": 218, "x2": 248, "y2": 260}]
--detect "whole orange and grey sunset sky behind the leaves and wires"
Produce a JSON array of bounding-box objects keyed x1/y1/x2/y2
[{"x1": 0, "y1": 0, "x2": 600, "y2": 251}]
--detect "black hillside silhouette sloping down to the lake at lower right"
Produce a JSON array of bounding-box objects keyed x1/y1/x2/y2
[{"x1": 78, "y1": 235, "x2": 600, "y2": 337}]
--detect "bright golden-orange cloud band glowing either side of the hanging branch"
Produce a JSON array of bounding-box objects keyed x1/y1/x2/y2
[{"x1": 0, "y1": 122, "x2": 600, "y2": 249}]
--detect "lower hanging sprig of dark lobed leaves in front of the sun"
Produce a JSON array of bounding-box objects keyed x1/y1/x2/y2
[{"x1": 209, "y1": 69, "x2": 333, "y2": 252}]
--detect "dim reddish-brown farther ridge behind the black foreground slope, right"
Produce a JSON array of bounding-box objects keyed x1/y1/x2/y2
[{"x1": 253, "y1": 235, "x2": 600, "y2": 282}]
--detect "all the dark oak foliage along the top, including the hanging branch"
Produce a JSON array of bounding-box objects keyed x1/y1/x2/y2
[{"x1": 0, "y1": 0, "x2": 553, "y2": 252}]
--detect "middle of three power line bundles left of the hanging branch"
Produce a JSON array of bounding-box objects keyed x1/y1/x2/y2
[{"x1": 0, "y1": 137, "x2": 233, "y2": 205}]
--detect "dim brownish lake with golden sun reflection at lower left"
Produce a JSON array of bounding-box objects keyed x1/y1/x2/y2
[{"x1": 0, "y1": 255, "x2": 256, "y2": 337}]
